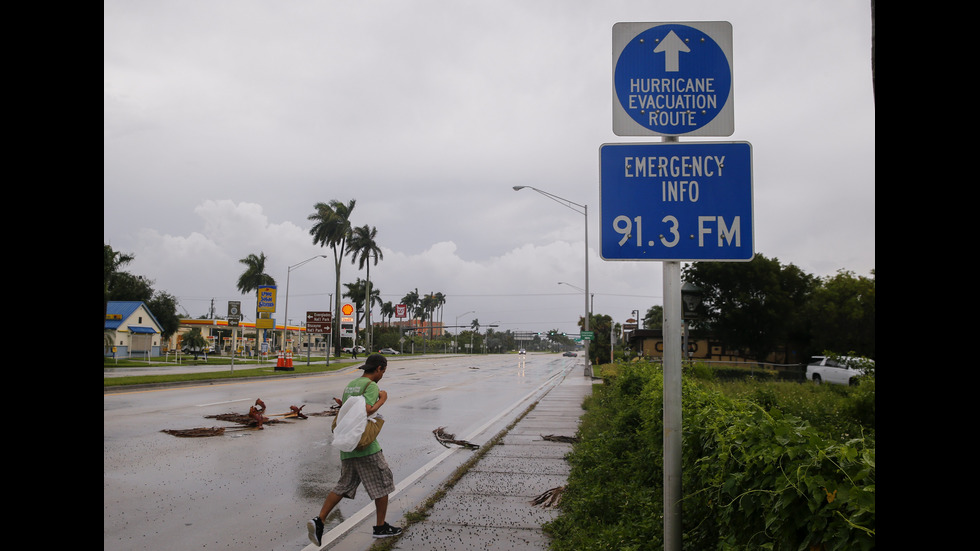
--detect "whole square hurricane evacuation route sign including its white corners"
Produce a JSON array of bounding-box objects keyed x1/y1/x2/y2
[{"x1": 613, "y1": 21, "x2": 735, "y2": 136}]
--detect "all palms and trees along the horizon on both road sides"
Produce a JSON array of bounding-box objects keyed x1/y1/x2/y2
[{"x1": 104, "y1": 211, "x2": 875, "y2": 363}]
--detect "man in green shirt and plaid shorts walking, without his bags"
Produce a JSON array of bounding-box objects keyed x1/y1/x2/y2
[{"x1": 306, "y1": 354, "x2": 402, "y2": 545}]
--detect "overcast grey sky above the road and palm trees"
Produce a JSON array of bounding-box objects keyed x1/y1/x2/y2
[{"x1": 103, "y1": 0, "x2": 875, "y2": 338}]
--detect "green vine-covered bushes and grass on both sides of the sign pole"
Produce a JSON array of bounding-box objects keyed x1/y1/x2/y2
[{"x1": 548, "y1": 363, "x2": 875, "y2": 551}]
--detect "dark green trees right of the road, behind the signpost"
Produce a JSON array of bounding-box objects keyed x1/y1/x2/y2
[{"x1": 579, "y1": 254, "x2": 875, "y2": 363}]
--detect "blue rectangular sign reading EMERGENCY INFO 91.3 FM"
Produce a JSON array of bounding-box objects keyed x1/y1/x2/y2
[{"x1": 599, "y1": 142, "x2": 754, "y2": 261}]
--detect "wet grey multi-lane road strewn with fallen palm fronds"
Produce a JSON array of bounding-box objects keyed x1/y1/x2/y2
[{"x1": 103, "y1": 354, "x2": 580, "y2": 551}]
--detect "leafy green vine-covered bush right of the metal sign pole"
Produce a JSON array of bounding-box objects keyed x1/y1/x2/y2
[{"x1": 684, "y1": 396, "x2": 875, "y2": 550}]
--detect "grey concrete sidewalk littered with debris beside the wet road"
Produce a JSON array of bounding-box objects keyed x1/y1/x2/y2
[{"x1": 394, "y1": 366, "x2": 592, "y2": 551}]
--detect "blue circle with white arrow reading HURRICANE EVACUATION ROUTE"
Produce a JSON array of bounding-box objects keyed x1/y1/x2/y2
[{"x1": 613, "y1": 24, "x2": 732, "y2": 135}]
